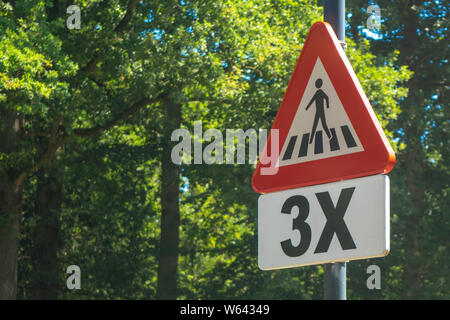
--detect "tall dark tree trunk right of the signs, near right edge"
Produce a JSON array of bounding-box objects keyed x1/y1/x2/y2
[{"x1": 400, "y1": 1, "x2": 425, "y2": 299}]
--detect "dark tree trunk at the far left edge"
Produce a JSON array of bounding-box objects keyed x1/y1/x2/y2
[{"x1": 0, "y1": 106, "x2": 23, "y2": 300}]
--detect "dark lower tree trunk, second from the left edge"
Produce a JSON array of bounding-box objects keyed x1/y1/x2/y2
[{"x1": 30, "y1": 166, "x2": 62, "y2": 300}]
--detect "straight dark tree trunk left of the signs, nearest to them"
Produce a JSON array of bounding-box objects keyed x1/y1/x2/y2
[{"x1": 156, "y1": 99, "x2": 181, "y2": 300}]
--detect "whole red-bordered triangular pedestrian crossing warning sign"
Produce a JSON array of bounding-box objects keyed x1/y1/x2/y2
[{"x1": 252, "y1": 22, "x2": 395, "y2": 193}]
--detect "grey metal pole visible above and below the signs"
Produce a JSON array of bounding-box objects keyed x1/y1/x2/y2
[{"x1": 323, "y1": 0, "x2": 347, "y2": 300}]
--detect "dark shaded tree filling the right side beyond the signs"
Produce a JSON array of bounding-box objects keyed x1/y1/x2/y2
[{"x1": 349, "y1": 1, "x2": 449, "y2": 299}]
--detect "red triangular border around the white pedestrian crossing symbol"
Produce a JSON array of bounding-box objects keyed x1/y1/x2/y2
[{"x1": 252, "y1": 22, "x2": 395, "y2": 193}]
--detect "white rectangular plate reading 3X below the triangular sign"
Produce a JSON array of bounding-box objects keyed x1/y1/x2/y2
[{"x1": 258, "y1": 174, "x2": 390, "y2": 270}]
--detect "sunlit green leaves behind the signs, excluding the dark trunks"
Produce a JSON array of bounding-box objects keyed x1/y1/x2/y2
[{"x1": 7, "y1": 0, "x2": 449, "y2": 299}]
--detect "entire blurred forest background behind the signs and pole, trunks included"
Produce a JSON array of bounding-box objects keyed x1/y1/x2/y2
[{"x1": 0, "y1": 0, "x2": 450, "y2": 299}]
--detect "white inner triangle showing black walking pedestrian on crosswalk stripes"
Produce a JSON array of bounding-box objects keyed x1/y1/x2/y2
[{"x1": 278, "y1": 58, "x2": 364, "y2": 166}]
